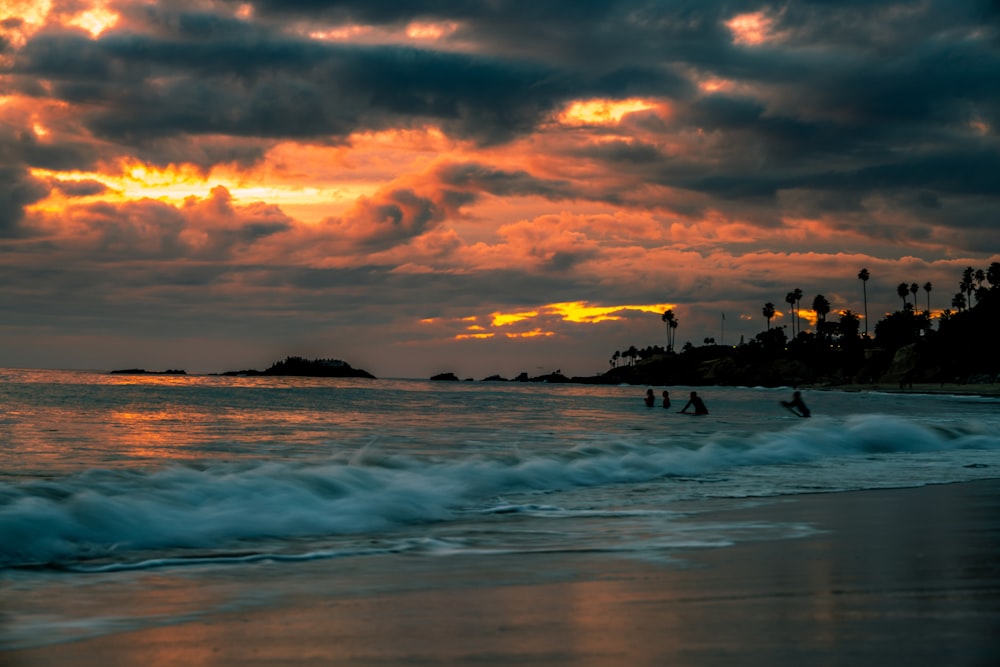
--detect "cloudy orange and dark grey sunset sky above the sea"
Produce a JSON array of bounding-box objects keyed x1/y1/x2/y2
[{"x1": 0, "y1": 0, "x2": 1000, "y2": 379}]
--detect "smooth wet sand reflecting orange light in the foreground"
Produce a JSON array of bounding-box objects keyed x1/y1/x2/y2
[{"x1": 7, "y1": 480, "x2": 1000, "y2": 667}]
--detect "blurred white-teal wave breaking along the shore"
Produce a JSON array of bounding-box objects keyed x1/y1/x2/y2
[{"x1": 0, "y1": 415, "x2": 1000, "y2": 566}]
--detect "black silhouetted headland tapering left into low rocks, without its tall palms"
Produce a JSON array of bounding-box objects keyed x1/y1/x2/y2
[{"x1": 466, "y1": 285, "x2": 1000, "y2": 395}]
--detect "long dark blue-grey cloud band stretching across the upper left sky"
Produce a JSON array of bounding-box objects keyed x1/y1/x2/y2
[{"x1": 7, "y1": 27, "x2": 573, "y2": 142}]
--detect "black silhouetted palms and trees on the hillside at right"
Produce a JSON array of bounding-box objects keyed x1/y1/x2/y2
[{"x1": 605, "y1": 262, "x2": 1000, "y2": 384}]
